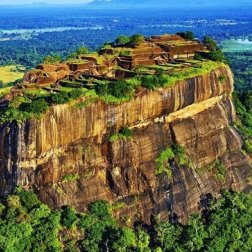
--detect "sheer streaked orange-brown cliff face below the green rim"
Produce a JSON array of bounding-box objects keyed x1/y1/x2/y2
[{"x1": 0, "y1": 67, "x2": 251, "y2": 222}]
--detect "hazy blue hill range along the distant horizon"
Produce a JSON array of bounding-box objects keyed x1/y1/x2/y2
[{"x1": 87, "y1": 0, "x2": 252, "y2": 9}]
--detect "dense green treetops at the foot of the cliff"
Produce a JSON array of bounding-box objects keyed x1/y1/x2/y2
[{"x1": 0, "y1": 188, "x2": 252, "y2": 252}]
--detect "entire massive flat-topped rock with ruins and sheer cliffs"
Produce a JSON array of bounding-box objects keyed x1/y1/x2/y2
[{"x1": 0, "y1": 35, "x2": 251, "y2": 223}]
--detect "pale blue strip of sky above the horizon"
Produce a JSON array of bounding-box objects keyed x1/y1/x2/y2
[{"x1": 0, "y1": 0, "x2": 91, "y2": 5}]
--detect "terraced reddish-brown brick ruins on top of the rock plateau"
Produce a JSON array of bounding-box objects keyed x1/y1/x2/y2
[{"x1": 1, "y1": 34, "x2": 207, "y2": 103}]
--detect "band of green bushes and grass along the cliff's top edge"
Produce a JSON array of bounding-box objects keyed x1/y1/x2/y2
[{"x1": 0, "y1": 61, "x2": 224, "y2": 123}]
